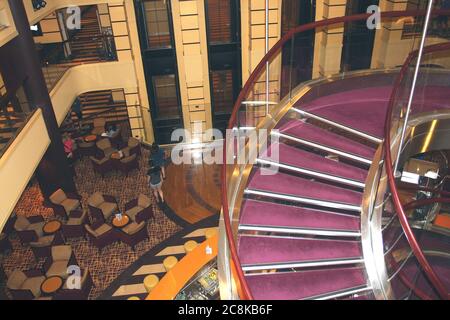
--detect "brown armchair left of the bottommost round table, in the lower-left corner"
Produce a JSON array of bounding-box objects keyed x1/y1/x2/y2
[{"x1": 6, "y1": 270, "x2": 45, "y2": 300}]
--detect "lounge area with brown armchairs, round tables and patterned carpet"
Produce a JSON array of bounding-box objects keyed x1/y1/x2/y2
[{"x1": 0, "y1": 144, "x2": 180, "y2": 300}]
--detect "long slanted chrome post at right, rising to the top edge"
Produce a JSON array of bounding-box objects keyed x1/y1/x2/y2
[{"x1": 392, "y1": 0, "x2": 433, "y2": 175}]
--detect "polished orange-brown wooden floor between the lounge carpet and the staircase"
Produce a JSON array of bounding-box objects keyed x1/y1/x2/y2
[{"x1": 163, "y1": 149, "x2": 221, "y2": 223}]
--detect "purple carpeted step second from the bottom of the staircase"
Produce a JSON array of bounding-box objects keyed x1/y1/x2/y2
[{"x1": 238, "y1": 235, "x2": 362, "y2": 266}]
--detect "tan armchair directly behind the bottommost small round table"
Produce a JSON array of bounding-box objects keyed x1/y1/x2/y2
[{"x1": 44, "y1": 245, "x2": 78, "y2": 279}]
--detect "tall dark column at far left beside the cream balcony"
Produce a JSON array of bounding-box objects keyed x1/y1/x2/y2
[{"x1": 1, "y1": 0, "x2": 76, "y2": 198}]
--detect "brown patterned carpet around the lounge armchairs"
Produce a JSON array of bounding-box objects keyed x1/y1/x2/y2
[{"x1": 0, "y1": 149, "x2": 182, "y2": 299}]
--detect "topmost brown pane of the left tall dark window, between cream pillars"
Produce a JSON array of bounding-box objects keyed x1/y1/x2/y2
[{"x1": 144, "y1": 0, "x2": 172, "y2": 49}]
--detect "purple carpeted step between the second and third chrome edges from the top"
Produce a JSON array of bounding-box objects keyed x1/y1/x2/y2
[{"x1": 261, "y1": 143, "x2": 367, "y2": 182}]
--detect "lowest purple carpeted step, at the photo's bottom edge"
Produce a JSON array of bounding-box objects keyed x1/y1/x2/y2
[{"x1": 246, "y1": 268, "x2": 366, "y2": 300}]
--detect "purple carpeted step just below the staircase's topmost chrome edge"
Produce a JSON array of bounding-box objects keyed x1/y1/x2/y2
[{"x1": 279, "y1": 120, "x2": 375, "y2": 160}]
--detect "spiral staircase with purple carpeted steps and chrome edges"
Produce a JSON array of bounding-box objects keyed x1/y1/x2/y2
[{"x1": 222, "y1": 9, "x2": 450, "y2": 300}]
